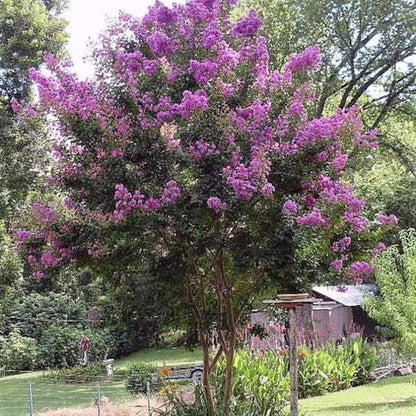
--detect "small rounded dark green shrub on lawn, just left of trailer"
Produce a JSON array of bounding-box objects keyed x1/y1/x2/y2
[{"x1": 126, "y1": 362, "x2": 159, "y2": 395}]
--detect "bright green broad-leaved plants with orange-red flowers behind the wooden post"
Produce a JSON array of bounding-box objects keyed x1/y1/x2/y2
[{"x1": 213, "y1": 337, "x2": 377, "y2": 416}]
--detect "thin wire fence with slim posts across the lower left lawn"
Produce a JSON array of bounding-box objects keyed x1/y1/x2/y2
[{"x1": 0, "y1": 373, "x2": 153, "y2": 416}]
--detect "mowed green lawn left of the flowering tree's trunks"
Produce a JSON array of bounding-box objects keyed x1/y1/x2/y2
[{"x1": 0, "y1": 348, "x2": 202, "y2": 416}]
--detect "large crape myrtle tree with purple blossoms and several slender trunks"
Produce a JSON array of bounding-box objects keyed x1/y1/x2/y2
[{"x1": 15, "y1": 0, "x2": 396, "y2": 415}]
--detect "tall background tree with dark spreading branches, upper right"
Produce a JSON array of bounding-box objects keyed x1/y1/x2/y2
[{"x1": 240, "y1": 0, "x2": 416, "y2": 238}]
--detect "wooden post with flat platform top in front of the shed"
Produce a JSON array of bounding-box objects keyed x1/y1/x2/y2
[{"x1": 263, "y1": 293, "x2": 316, "y2": 416}]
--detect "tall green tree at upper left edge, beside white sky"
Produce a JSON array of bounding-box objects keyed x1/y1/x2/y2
[{"x1": 0, "y1": 0, "x2": 67, "y2": 218}]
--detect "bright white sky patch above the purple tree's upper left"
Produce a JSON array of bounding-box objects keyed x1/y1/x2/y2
[{"x1": 64, "y1": 0, "x2": 182, "y2": 78}]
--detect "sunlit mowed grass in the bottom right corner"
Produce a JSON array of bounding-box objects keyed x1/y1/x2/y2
[{"x1": 300, "y1": 374, "x2": 416, "y2": 416}]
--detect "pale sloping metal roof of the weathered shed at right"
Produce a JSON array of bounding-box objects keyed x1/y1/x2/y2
[{"x1": 312, "y1": 284, "x2": 377, "y2": 306}]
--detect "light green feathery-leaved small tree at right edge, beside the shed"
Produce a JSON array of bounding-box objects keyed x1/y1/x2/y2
[{"x1": 364, "y1": 229, "x2": 416, "y2": 354}]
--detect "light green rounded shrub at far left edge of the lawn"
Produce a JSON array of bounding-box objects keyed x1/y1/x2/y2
[{"x1": 0, "y1": 328, "x2": 39, "y2": 371}]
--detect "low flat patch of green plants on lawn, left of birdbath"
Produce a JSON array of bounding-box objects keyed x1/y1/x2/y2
[{"x1": 43, "y1": 363, "x2": 107, "y2": 384}]
